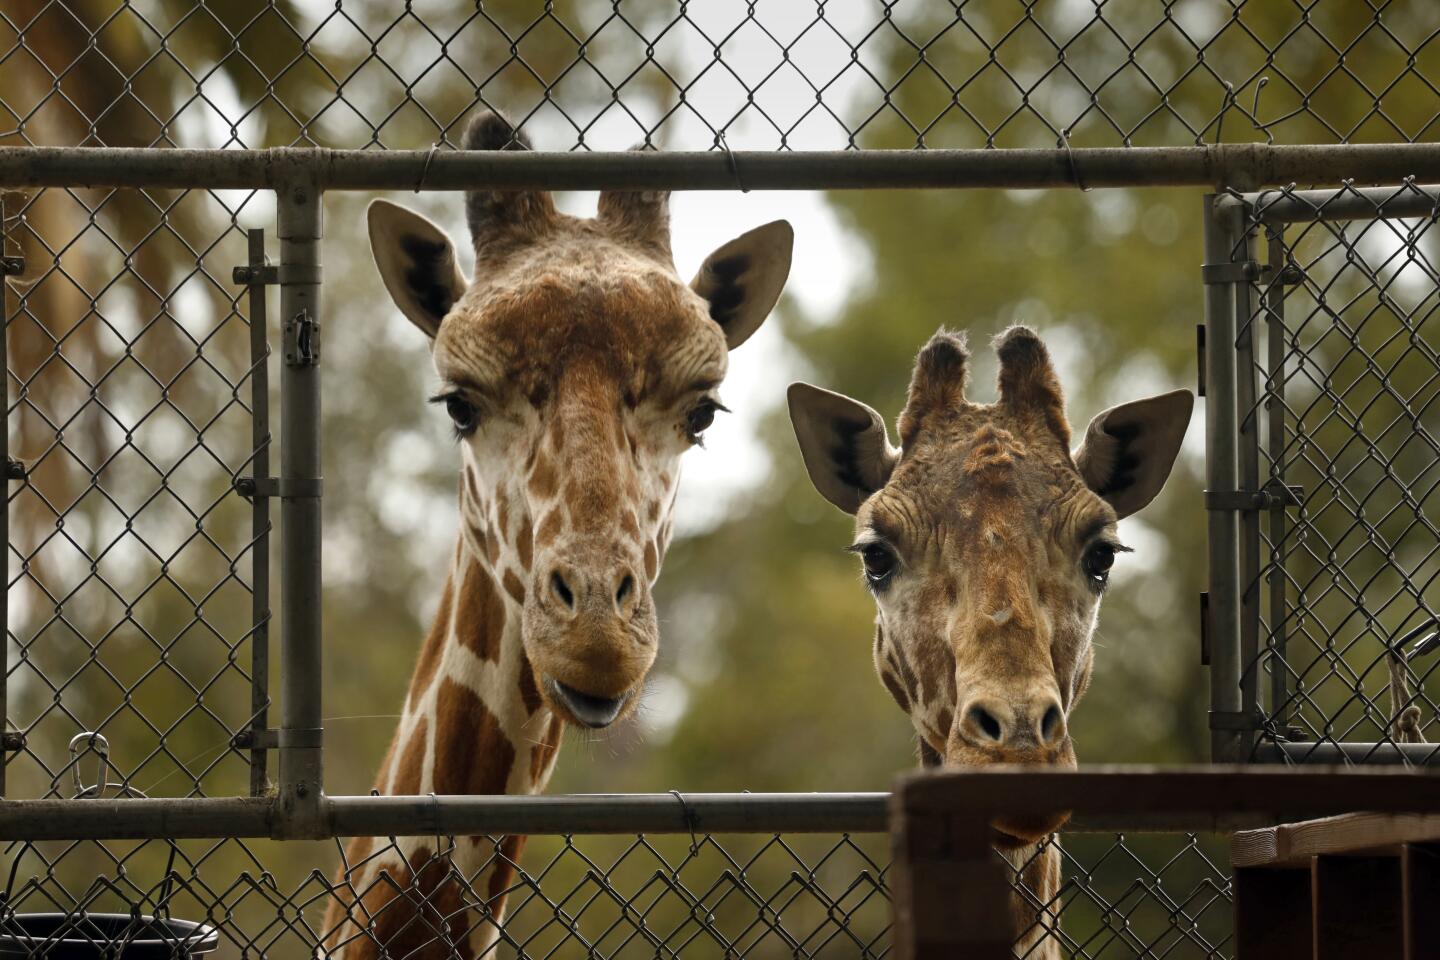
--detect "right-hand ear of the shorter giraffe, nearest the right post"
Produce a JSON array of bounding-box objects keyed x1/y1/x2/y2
[{"x1": 1074, "y1": 390, "x2": 1195, "y2": 517}]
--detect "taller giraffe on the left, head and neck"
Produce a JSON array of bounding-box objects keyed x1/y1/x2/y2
[{"x1": 320, "y1": 112, "x2": 793, "y2": 960}]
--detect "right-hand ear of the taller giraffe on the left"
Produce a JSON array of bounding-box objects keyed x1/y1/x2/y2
[{"x1": 690, "y1": 220, "x2": 795, "y2": 350}]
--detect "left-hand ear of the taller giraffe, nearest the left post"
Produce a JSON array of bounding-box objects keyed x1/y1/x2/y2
[{"x1": 366, "y1": 200, "x2": 465, "y2": 340}]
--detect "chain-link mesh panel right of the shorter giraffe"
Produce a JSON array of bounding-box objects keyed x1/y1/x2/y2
[{"x1": 1241, "y1": 184, "x2": 1440, "y2": 759}]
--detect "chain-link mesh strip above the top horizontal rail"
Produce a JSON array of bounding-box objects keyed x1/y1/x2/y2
[{"x1": 8, "y1": 0, "x2": 1440, "y2": 150}]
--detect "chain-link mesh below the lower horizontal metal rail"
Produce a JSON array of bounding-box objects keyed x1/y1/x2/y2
[{"x1": 0, "y1": 835, "x2": 1230, "y2": 960}]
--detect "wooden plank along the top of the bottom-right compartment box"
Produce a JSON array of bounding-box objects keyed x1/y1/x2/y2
[{"x1": 1230, "y1": 813, "x2": 1440, "y2": 868}]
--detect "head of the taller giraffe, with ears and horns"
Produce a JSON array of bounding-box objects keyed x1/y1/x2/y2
[{"x1": 369, "y1": 114, "x2": 792, "y2": 727}]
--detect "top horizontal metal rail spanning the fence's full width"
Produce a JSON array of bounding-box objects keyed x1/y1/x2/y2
[{"x1": 8, "y1": 144, "x2": 1440, "y2": 190}]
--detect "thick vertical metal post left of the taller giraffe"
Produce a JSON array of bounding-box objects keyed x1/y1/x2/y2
[{"x1": 275, "y1": 172, "x2": 324, "y2": 836}]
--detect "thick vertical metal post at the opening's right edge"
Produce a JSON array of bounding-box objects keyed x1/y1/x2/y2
[{"x1": 1202, "y1": 194, "x2": 1244, "y2": 763}]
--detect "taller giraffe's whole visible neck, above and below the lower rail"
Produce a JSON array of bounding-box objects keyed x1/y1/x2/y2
[{"x1": 317, "y1": 538, "x2": 563, "y2": 960}]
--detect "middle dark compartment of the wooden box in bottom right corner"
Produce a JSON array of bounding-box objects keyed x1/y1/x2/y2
[{"x1": 1310, "y1": 856, "x2": 1404, "y2": 960}]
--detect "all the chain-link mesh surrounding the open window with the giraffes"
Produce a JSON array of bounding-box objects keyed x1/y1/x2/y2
[{"x1": 0, "y1": 0, "x2": 1440, "y2": 957}]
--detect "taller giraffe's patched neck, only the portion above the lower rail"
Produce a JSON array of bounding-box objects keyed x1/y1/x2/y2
[{"x1": 376, "y1": 531, "x2": 562, "y2": 794}]
